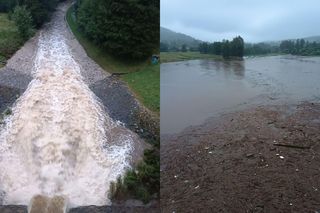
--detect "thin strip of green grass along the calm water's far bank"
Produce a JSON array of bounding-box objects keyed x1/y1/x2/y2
[{"x1": 160, "y1": 52, "x2": 222, "y2": 63}]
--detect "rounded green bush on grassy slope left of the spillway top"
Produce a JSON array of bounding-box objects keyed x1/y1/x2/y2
[{"x1": 12, "y1": 6, "x2": 33, "y2": 40}]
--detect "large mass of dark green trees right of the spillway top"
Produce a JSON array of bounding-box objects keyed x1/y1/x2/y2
[{"x1": 74, "y1": 0, "x2": 160, "y2": 59}]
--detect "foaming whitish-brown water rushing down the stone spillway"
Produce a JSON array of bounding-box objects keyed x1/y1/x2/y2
[{"x1": 0, "y1": 15, "x2": 133, "y2": 206}]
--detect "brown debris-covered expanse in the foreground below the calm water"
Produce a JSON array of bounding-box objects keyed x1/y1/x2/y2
[{"x1": 161, "y1": 103, "x2": 320, "y2": 213}]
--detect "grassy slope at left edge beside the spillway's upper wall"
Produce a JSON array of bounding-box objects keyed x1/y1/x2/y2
[{"x1": 0, "y1": 13, "x2": 24, "y2": 68}]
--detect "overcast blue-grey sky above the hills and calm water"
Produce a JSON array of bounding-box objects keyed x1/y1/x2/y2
[{"x1": 160, "y1": 0, "x2": 320, "y2": 42}]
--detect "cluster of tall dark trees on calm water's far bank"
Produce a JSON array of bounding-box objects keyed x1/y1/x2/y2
[{"x1": 199, "y1": 36, "x2": 244, "y2": 58}]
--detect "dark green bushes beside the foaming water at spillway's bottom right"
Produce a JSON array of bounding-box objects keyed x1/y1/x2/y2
[{"x1": 110, "y1": 142, "x2": 160, "y2": 203}]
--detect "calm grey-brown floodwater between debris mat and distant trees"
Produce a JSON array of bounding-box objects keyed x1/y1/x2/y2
[{"x1": 161, "y1": 56, "x2": 320, "y2": 134}]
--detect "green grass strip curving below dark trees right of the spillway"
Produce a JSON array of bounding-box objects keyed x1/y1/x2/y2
[{"x1": 66, "y1": 7, "x2": 160, "y2": 113}]
